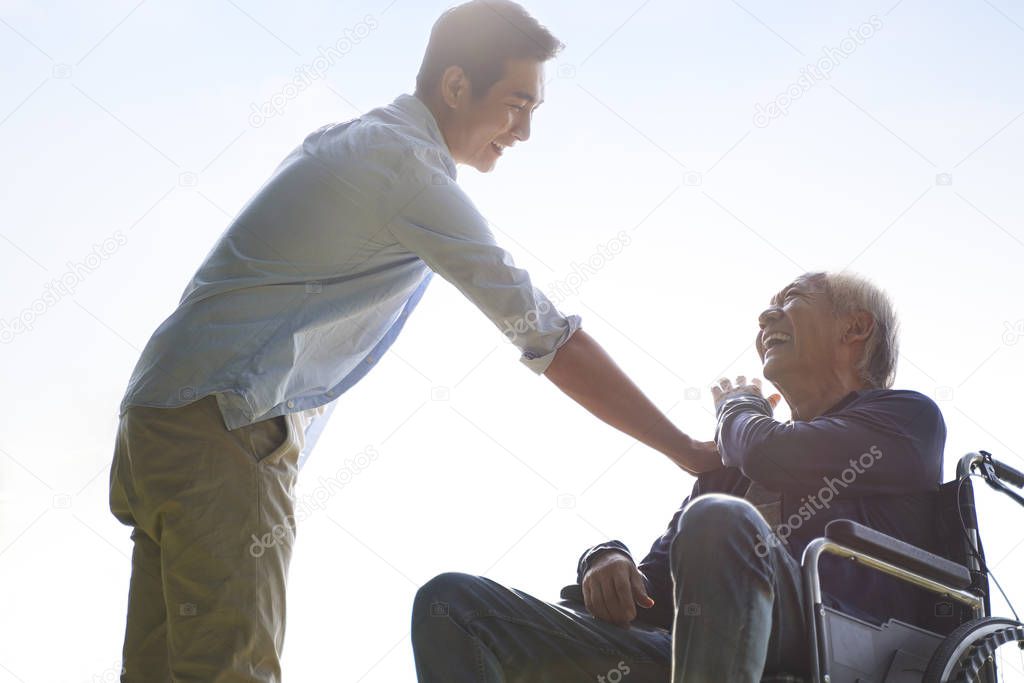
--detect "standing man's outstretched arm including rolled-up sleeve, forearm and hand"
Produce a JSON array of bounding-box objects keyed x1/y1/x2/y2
[{"x1": 385, "y1": 145, "x2": 722, "y2": 474}]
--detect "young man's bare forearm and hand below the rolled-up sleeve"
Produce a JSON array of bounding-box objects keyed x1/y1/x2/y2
[{"x1": 544, "y1": 330, "x2": 722, "y2": 475}]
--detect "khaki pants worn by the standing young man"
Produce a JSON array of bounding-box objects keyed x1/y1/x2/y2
[{"x1": 110, "y1": 395, "x2": 304, "y2": 683}]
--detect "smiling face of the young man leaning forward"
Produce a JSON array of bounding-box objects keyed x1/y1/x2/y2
[{"x1": 440, "y1": 59, "x2": 544, "y2": 173}]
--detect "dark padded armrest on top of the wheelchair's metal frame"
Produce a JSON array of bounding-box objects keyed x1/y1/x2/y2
[{"x1": 825, "y1": 519, "x2": 971, "y2": 590}]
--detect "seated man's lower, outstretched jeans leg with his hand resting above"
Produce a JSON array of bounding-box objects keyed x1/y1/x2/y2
[{"x1": 413, "y1": 573, "x2": 672, "y2": 683}]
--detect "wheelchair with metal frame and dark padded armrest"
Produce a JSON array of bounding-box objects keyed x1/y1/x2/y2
[{"x1": 561, "y1": 451, "x2": 1024, "y2": 683}]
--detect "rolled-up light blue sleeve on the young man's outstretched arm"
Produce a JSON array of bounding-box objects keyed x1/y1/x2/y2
[{"x1": 384, "y1": 141, "x2": 580, "y2": 374}]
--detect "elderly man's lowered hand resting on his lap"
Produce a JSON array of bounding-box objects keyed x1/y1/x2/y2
[{"x1": 583, "y1": 550, "x2": 654, "y2": 627}]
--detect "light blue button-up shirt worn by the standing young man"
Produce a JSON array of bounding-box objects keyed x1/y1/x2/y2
[{"x1": 120, "y1": 95, "x2": 580, "y2": 467}]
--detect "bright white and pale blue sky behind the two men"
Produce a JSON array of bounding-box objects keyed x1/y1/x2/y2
[{"x1": 0, "y1": 0, "x2": 1024, "y2": 683}]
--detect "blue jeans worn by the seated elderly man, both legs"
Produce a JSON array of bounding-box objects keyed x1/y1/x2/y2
[{"x1": 413, "y1": 494, "x2": 808, "y2": 683}]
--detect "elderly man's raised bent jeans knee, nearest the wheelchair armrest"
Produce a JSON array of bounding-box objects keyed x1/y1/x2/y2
[{"x1": 671, "y1": 494, "x2": 810, "y2": 683}]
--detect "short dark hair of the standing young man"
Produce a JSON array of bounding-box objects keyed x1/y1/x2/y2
[{"x1": 416, "y1": 0, "x2": 564, "y2": 98}]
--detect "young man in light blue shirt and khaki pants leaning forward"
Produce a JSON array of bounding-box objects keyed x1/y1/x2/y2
[{"x1": 111, "y1": 0, "x2": 718, "y2": 681}]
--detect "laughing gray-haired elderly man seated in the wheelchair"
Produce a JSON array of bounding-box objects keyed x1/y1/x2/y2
[{"x1": 405, "y1": 273, "x2": 945, "y2": 683}]
